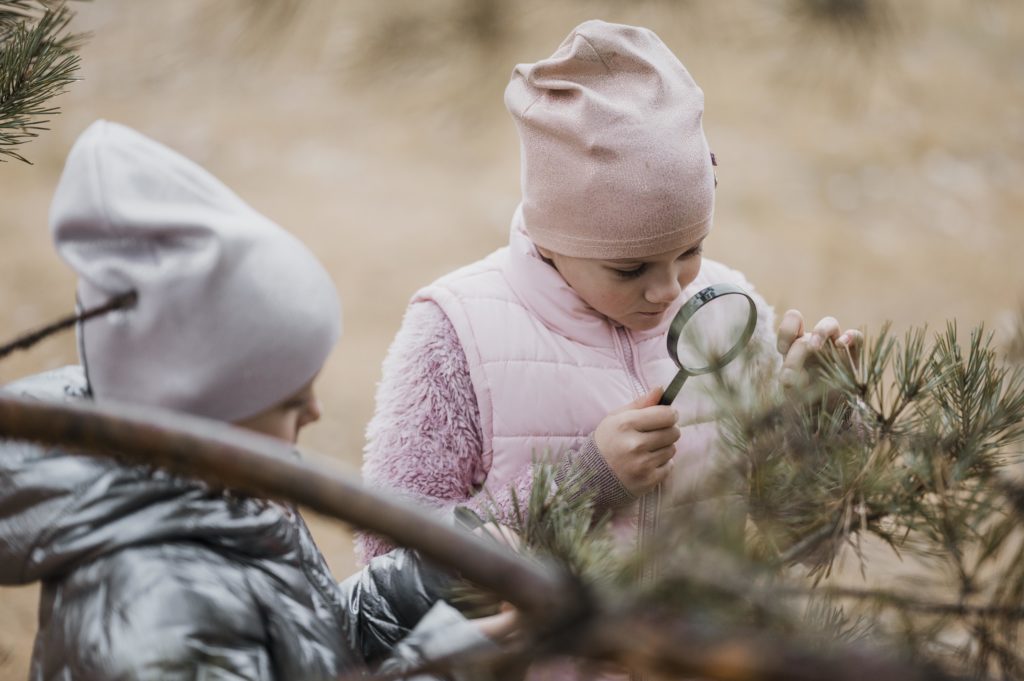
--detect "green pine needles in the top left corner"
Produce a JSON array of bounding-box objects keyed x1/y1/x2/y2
[{"x1": 0, "y1": 0, "x2": 82, "y2": 163}]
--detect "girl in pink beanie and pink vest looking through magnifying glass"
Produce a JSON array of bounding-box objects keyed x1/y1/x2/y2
[{"x1": 359, "y1": 20, "x2": 855, "y2": 559}]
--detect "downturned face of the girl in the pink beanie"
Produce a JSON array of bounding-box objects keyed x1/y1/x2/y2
[{"x1": 538, "y1": 237, "x2": 703, "y2": 331}]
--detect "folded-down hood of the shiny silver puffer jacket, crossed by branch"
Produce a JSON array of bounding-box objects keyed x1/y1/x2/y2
[{"x1": 0, "y1": 367, "x2": 297, "y2": 585}]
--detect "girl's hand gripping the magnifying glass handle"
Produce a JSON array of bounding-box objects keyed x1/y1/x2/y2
[{"x1": 594, "y1": 388, "x2": 679, "y2": 497}]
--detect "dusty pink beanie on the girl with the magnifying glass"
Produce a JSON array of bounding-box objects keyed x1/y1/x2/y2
[{"x1": 505, "y1": 20, "x2": 715, "y2": 259}]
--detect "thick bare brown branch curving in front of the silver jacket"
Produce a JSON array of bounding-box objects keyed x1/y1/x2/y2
[{"x1": 0, "y1": 394, "x2": 578, "y2": 622}]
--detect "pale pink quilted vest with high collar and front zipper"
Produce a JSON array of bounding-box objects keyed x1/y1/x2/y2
[{"x1": 414, "y1": 212, "x2": 773, "y2": 515}]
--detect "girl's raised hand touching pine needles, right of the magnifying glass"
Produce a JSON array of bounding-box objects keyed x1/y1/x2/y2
[{"x1": 778, "y1": 309, "x2": 864, "y2": 389}]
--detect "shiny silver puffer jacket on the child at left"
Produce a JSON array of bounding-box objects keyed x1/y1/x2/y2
[{"x1": 0, "y1": 368, "x2": 486, "y2": 681}]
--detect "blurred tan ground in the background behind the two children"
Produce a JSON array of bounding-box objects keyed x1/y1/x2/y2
[{"x1": 0, "y1": 0, "x2": 1024, "y2": 679}]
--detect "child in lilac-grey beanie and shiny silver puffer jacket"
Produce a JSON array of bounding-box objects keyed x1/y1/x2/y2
[{"x1": 0, "y1": 122, "x2": 500, "y2": 680}]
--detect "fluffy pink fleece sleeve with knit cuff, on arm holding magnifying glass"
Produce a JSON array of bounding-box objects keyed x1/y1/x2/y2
[{"x1": 356, "y1": 302, "x2": 632, "y2": 561}]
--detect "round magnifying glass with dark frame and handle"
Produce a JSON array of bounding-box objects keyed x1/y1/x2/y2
[{"x1": 658, "y1": 284, "x2": 758, "y2": 405}]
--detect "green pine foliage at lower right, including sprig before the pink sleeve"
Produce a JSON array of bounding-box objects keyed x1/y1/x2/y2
[{"x1": 516, "y1": 325, "x2": 1024, "y2": 678}]
